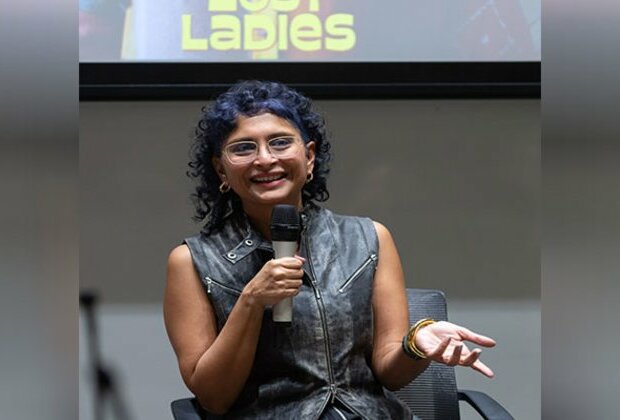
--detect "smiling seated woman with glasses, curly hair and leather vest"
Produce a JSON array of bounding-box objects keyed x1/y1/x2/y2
[{"x1": 164, "y1": 81, "x2": 495, "y2": 419}]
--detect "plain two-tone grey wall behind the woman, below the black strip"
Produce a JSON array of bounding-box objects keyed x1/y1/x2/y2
[{"x1": 80, "y1": 99, "x2": 540, "y2": 419}]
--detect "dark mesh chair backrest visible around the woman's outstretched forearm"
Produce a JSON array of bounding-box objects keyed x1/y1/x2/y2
[{"x1": 395, "y1": 289, "x2": 460, "y2": 420}]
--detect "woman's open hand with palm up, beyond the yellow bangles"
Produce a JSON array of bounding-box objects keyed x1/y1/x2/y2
[{"x1": 415, "y1": 321, "x2": 495, "y2": 378}]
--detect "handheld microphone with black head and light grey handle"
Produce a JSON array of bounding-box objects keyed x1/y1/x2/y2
[{"x1": 271, "y1": 204, "x2": 301, "y2": 322}]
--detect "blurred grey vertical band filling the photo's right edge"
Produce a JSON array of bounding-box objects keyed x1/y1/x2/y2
[{"x1": 541, "y1": 0, "x2": 620, "y2": 420}]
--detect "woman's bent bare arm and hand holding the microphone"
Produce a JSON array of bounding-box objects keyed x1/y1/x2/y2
[{"x1": 164, "y1": 245, "x2": 302, "y2": 414}]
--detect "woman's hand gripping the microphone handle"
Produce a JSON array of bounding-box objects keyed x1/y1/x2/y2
[{"x1": 243, "y1": 255, "x2": 305, "y2": 307}]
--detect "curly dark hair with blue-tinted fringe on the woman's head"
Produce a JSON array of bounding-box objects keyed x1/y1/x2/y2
[{"x1": 187, "y1": 80, "x2": 331, "y2": 235}]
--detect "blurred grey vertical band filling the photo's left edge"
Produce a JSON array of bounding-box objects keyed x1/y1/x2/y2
[{"x1": 0, "y1": 0, "x2": 79, "y2": 420}]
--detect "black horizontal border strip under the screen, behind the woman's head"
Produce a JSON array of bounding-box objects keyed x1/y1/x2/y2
[{"x1": 80, "y1": 62, "x2": 541, "y2": 100}]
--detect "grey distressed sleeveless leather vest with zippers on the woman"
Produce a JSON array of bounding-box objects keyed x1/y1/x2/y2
[{"x1": 185, "y1": 206, "x2": 411, "y2": 420}]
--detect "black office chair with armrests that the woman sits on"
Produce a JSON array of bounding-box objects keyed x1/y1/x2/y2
[{"x1": 171, "y1": 289, "x2": 514, "y2": 420}]
